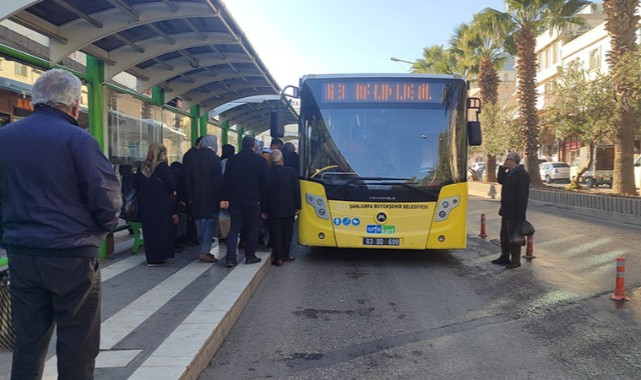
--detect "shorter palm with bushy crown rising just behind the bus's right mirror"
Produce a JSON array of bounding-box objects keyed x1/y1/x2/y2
[{"x1": 450, "y1": 14, "x2": 511, "y2": 182}]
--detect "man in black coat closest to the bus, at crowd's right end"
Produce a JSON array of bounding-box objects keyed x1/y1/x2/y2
[{"x1": 262, "y1": 149, "x2": 301, "y2": 266}]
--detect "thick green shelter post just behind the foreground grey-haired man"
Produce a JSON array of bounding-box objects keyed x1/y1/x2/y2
[{"x1": 87, "y1": 55, "x2": 107, "y2": 259}]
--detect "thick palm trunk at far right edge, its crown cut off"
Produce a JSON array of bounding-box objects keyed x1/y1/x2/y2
[{"x1": 603, "y1": 0, "x2": 639, "y2": 194}]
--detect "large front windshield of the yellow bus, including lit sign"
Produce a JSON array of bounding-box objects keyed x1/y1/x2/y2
[{"x1": 301, "y1": 79, "x2": 467, "y2": 200}]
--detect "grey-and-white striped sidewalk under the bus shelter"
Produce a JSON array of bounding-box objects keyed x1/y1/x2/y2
[{"x1": 0, "y1": 231, "x2": 271, "y2": 380}]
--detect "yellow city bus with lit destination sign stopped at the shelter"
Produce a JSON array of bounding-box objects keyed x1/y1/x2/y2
[{"x1": 286, "y1": 74, "x2": 481, "y2": 250}]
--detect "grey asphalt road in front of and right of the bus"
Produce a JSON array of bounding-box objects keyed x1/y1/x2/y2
[{"x1": 201, "y1": 199, "x2": 641, "y2": 379}]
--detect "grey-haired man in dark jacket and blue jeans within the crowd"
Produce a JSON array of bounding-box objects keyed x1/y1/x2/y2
[{"x1": 183, "y1": 135, "x2": 223, "y2": 262}]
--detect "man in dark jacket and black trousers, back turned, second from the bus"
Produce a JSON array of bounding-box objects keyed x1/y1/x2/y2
[{"x1": 221, "y1": 136, "x2": 269, "y2": 267}]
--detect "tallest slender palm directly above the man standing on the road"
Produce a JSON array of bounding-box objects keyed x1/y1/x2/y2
[{"x1": 482, "y1": 0, "x2": 590, "y2": 185}]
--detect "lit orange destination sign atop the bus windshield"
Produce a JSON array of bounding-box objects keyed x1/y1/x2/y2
[{"x1": 322, "y1": 80, "x2": 445, "y2": 103}]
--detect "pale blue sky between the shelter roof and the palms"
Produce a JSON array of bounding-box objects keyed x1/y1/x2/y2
[{"x1": 222, "y1": 0, "x2": 504, "y2": 88}]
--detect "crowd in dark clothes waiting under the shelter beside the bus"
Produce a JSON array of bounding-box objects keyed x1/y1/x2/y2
[{"x1": 132, "y1": 135, "x2": 300, "y2": 267}]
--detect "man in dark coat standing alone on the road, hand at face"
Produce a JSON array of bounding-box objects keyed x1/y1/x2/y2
[{"x1": 492, "y1": 152, "x2": 530, "y2": 269}]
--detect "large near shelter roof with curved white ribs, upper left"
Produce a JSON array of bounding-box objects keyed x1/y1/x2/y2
[{"x1": 0, "y1": 0, "x2": 292, "y2": 133}]
